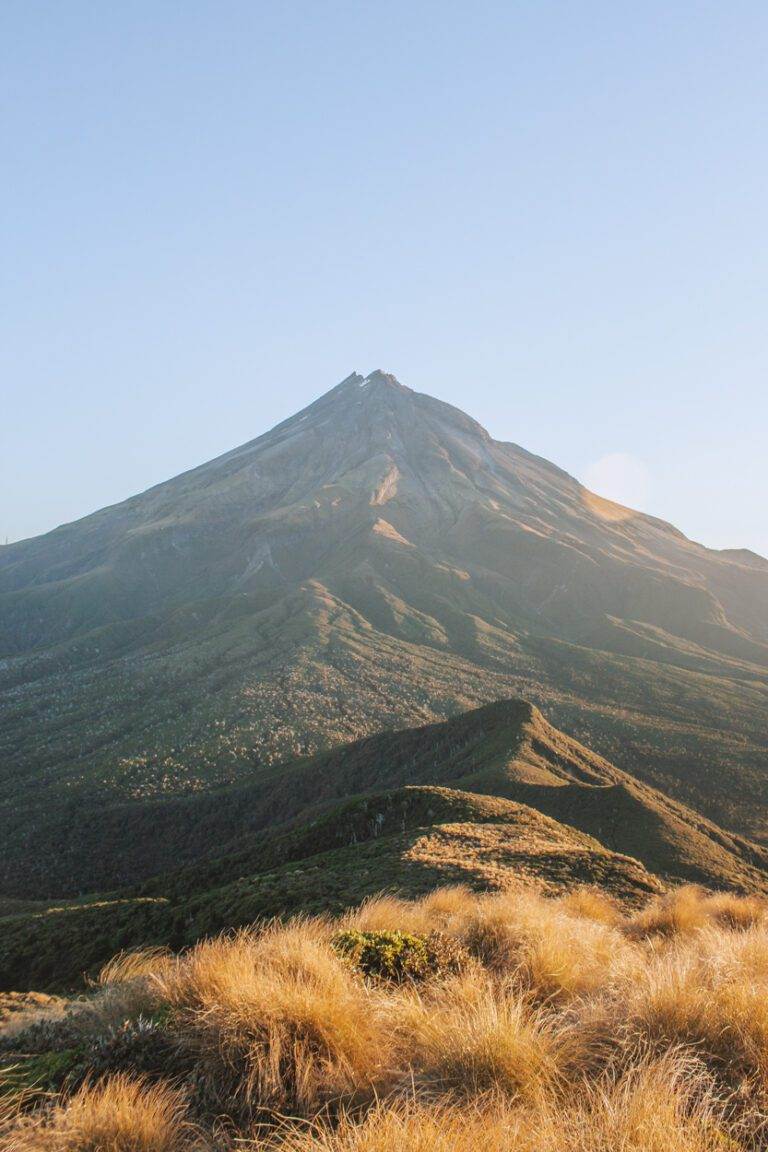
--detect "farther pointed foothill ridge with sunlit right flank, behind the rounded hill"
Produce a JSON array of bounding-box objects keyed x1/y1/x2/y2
[{"x1": 0, "y1": 700, "x2": 768, "y2": 899}]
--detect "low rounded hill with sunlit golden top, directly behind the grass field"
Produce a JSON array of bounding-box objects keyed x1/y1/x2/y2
[{"x1": 0, "y1": 787, "x2": 663, "y2": 990}]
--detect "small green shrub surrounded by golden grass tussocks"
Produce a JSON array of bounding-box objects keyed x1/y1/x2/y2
[{"x1": 332, "y1": 929, "x2": 467, "y2": 984}]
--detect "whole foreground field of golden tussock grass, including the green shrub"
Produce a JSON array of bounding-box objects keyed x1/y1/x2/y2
[{"x1": 0, "y1": 887, "x2": 768, "y2": 1152}]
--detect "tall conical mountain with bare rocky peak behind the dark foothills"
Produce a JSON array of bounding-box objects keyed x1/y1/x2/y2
[{"x1": 0, "y1": 372, "x2": 768, "y2": 895}]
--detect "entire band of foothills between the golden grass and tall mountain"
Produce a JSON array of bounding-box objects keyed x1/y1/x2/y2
[{"x1": 0, "y1": 700, "x2": 768, "y2": 990}]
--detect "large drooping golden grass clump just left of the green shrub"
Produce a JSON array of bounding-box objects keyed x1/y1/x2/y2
[{"x1": 157, "y1": 922, "x2": 388, "y2": 1114}]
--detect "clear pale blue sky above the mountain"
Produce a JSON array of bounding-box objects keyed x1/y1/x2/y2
[{"x1": 0, "y1": 0, "x2": 768, "y2": 554}]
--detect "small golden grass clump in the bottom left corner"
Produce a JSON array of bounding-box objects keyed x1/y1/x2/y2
[{"x1": 6, "y1": 1075, "x2": 204, "y2": 1152}]
